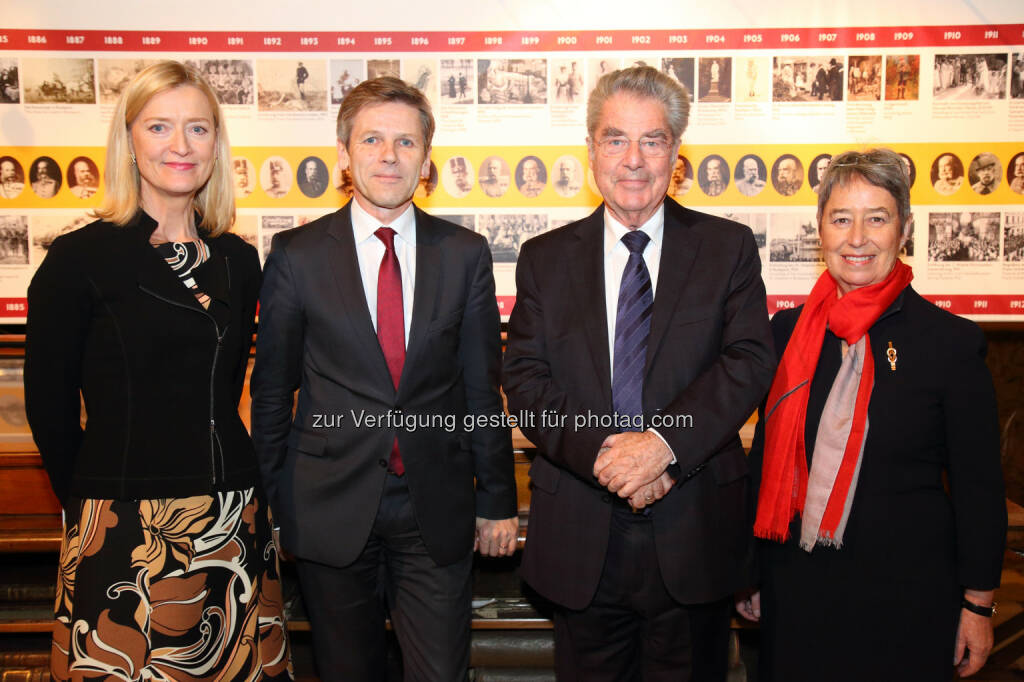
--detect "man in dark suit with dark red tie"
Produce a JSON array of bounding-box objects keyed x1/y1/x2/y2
[{"x1": 252, "y1": 78, "x2": 517, "y2": 681}]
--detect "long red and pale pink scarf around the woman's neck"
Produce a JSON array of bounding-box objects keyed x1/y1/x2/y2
[{"x1": 754, "y1": 260, "x2": 913, "y2": 552}]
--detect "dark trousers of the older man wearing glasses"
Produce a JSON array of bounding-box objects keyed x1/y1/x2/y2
[{"x1": 554, "y1": 508, "x2": 732, "y2": 682}]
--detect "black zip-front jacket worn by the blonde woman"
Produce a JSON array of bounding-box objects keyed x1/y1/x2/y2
[{"x1": 25, "y1": 211, "x2": 260, "y2": 504}]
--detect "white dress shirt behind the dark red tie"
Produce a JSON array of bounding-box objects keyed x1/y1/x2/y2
[{"x1": 351, "y1": 199, "x2": 416, "y2": 348}]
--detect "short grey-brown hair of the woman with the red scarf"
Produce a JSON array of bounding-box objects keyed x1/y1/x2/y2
[{"x1": 818, "y1": 147, "x2": 910, "y2": 227}]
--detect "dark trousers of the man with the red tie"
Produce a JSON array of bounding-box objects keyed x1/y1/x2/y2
[{"x1": 298, "y1": 474, "x2": 473, "y2": 682}]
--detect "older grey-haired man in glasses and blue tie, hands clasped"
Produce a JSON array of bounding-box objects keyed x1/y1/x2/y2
[{"x1": 504, "y1": 67, "x2": 775, "y2": 682}]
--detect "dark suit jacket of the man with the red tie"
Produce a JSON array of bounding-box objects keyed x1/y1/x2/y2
[{"x1": 252, "y1": 200, "x2": 516, "y2": 566}]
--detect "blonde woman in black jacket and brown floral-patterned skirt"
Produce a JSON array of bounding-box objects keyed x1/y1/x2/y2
[{"x1": 25, "y1": 61, "x2": 291, "y2": 680}]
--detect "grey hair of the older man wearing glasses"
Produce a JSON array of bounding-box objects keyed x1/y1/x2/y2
[{"x1": 587, "y1": 67, "x2": 690, "y2": 144}]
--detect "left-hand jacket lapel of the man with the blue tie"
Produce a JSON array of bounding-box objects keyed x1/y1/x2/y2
[{"x1": 566, "y1": 205, "x2": 611, "y2": 404}]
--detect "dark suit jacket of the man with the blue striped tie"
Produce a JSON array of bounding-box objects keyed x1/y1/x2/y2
[{"x1": 505, "y1": 200, "x2": 775, "y2": 608}]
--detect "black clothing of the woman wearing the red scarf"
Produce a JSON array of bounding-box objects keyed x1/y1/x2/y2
[{"x1": 751, "y1": 287, "x2": 1007, "y2": 682}]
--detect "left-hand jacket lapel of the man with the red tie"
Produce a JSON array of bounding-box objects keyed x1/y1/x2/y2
[{"x1": 327, "y1": 204, "x2": 395, "y2": 396}]
